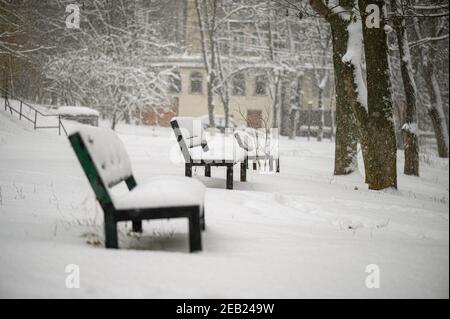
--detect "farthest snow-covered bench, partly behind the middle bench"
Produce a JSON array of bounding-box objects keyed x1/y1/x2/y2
[{"x1": 234, "y1": 128, "x2": 280, "y2": 173}]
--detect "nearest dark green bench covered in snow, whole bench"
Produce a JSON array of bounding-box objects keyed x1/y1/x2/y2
[{"x1": 69, "y1": 127, "x2": 205, "y2": 251}]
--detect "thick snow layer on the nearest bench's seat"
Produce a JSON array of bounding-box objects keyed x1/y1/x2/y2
[{"x1": 112, "y1": 176, "x2": 206, "y2": 209}]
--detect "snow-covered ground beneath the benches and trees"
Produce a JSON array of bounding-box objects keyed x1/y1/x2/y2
[{"x1": 0, "y1": 110, "x2": 449, "y2": 298}]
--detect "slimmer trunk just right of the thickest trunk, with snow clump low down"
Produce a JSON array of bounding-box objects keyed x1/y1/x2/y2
[{"x1": 391, "y1": 0, "x2": 419, "y2": 176}]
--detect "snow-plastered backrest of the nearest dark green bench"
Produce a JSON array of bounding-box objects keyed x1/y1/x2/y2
[{"x1": 69, "y1": 127, "x2": 136, "y2": 206}]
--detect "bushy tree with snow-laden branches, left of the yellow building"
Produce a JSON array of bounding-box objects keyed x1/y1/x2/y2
[{"x1": 40, "y1": 0, "x2": 175, "y2": 126}]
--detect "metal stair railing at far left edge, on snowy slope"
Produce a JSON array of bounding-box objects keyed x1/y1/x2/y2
[{"x1": 0, "y1": 88, "x2": 67, "y2": 136}]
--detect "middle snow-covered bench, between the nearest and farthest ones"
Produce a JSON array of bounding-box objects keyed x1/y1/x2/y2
[{"x1": 170, "y1": 117, "x2": 247, "y2": 189}]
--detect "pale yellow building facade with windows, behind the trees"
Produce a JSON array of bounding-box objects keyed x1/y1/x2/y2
[{"x1": 149, "y1": 0, "x2": 334, "y2": 131}]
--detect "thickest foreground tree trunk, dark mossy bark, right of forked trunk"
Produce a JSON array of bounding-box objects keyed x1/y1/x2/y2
[{"x1": 359, "y1": 0, "x2": 397, "y2": 190}]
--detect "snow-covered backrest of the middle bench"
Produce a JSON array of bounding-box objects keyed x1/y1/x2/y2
[{"x1": 170, "y1": 116, "x2": 207, "y2": 162}]
